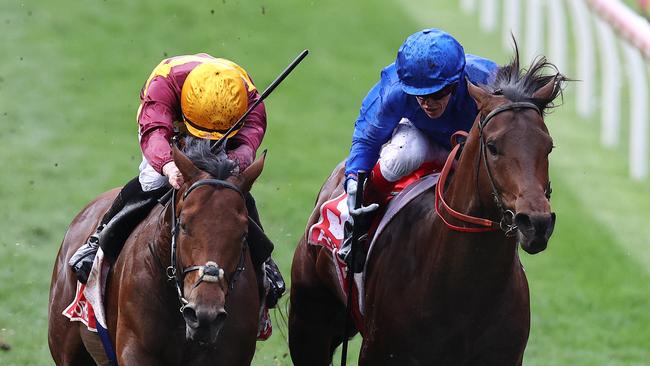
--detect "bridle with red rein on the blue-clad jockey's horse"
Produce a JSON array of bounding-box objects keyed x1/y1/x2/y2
[{"x1": 435, "y1": 102, "x2": 550, "y2": 236}]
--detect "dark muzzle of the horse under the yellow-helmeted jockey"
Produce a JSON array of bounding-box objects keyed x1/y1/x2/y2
[{"x1": 183, "y1": 303, "x2": 228, "y2": 344}]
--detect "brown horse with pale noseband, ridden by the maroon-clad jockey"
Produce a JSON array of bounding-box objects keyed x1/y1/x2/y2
[{"x1": 48, "y1": 141, "x2": 264, "y2": 366}]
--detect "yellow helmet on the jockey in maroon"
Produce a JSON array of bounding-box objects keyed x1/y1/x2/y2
[{"x1": 181, "y1": 63, "x2": 248, "y2": 140}]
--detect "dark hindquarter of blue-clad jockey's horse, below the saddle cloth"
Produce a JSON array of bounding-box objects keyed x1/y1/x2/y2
[{"x1": 289, "y1": 242, "x2": 345, "y2": 366}]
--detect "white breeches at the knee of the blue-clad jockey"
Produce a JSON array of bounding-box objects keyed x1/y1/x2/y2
[{"x1": 379, "y1": 118, "x2": 449, "y2": 182}]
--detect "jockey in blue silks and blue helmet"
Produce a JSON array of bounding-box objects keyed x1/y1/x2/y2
[{"x1": 339, "y1": 28, "x2": 497, "y2": 257}]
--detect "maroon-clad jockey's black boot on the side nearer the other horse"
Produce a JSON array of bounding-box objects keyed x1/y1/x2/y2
[{"x1": 246, "y1": 193, "x2": 286, "y2": 309}]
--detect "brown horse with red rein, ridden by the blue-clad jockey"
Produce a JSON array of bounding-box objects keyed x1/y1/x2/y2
[{"x1": 289, "y1": 55, "x2": 566, "y2": 366}]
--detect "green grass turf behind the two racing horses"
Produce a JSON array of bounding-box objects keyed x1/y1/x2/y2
[{"x1": 0, "y1": 0, "x2": 650, "y2": 365}]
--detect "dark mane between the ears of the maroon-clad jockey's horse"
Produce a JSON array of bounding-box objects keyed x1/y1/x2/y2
[{"x1": 183, "y1": 136, "x2": 237, "y2": 179}]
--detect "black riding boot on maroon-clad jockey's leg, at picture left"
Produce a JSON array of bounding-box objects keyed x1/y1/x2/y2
[{"x1": 68, "y1": 177, "x2": 169, "y2": 283}]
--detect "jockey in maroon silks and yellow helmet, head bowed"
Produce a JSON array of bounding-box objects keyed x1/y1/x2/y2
[{"x1": 69, "y1": 53, "x2": 285, "y2": 307}]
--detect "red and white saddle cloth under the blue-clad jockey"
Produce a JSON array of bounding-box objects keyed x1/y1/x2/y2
[{"x1": 307, "y1": 163, "x2": 441, "y2": 334}]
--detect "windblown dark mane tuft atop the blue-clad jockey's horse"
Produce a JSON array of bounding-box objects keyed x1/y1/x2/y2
[{"x1": 483, "y1": 37, "x2": 569, "y2": 112}]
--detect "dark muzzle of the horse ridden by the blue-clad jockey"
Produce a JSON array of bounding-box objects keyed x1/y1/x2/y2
[{"x1": 515, "y1": 212, "x2": 555, "y2": 254}]
